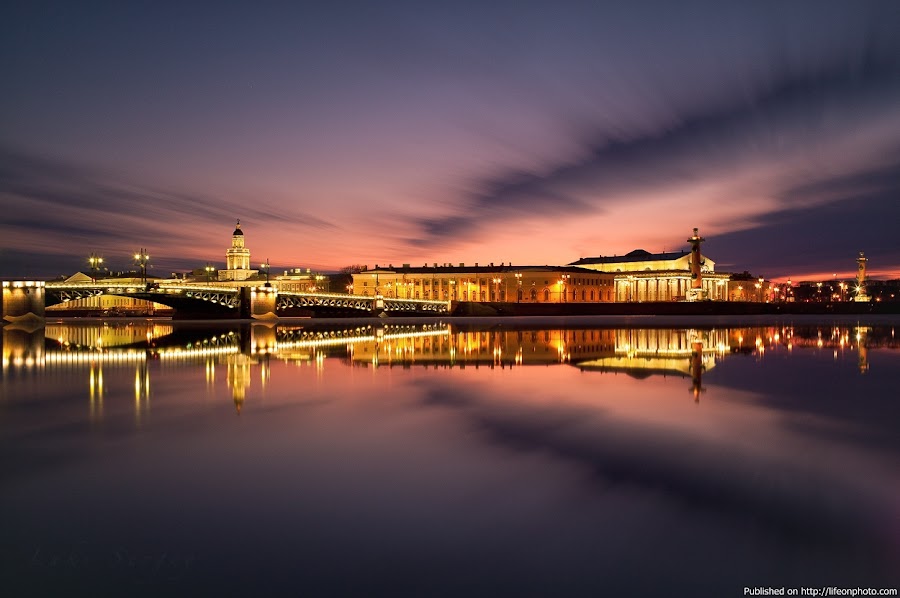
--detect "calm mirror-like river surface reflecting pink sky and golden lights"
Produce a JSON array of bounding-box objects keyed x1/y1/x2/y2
[{"x1": 0, "y1": 320, "x2": 900, "y2": 596}]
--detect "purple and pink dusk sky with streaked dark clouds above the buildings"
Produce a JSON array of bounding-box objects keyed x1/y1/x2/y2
[{"x1": 0, "y1": 0, "x2": 900, "y2": 280}]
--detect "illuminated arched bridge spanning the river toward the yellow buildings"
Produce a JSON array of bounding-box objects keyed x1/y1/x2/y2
[{"x1": 2, "y1": 280, "x2": 451, "y2": 321}]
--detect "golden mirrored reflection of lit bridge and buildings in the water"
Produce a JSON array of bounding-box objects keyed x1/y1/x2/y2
[{"x1": 2, "y1": 321, "x2": 898, "y2": 423}]
